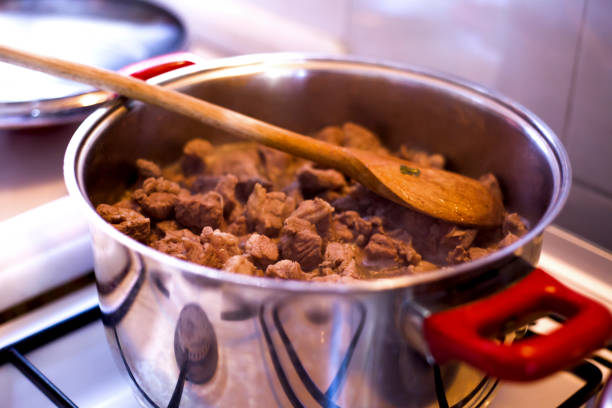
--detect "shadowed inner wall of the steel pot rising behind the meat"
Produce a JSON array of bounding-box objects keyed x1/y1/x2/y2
[{"x1": 78, "y1": 58, "x2": 569, "y2": 233}]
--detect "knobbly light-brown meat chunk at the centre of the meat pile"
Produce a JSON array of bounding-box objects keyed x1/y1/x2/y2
[{"x1": 245, "y1": 184, "x2": 295, "y2": 237}]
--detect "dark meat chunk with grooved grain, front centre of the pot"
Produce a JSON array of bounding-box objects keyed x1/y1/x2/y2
[{"x1": 278, "y1": 217, "x2": 323, "y2": 271}]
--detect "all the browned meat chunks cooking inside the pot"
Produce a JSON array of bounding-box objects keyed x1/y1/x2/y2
[{"x1": 96, "y1": 123, "x2": 527, "y2": 282}]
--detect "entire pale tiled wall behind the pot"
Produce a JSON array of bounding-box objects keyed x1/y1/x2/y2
[{"x1": 159, "y1": 0, "x2": 612, "y2": 249}]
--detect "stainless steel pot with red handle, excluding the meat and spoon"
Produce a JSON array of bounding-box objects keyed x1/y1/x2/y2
[{"x1": 64, "y1": 54, "x2": 612, "y2": 407}]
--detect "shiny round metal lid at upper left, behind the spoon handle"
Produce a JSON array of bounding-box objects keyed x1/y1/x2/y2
[{"x1": 0, "y1": 0, "x2": 186, "y2": 129}]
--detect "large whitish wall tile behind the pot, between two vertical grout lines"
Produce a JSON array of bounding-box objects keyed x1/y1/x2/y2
[{"x1": 348, "y1": 0, "x2": 583, "y2": 133}]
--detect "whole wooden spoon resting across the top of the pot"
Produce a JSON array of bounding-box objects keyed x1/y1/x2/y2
[{"x1": 0, "y1": 45, "x2": 503, "y2": 227}]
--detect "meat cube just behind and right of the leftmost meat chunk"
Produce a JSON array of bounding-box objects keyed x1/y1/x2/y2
[{"x1": 132, "y1": 177, "x2": 181, "y2": 220}]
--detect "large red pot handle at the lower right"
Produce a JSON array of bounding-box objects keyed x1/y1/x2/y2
[{"x1": 423, "y1": 269, "x2": 612, "y2": 381}]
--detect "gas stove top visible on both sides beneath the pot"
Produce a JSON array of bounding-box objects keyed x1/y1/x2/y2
[{"x1": 0, "y1": 197, "x2": 612, "y2": 408}]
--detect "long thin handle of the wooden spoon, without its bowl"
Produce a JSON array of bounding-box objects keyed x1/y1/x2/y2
[{"x1": 0, "y1": 45, "x2": 355, "y2": 174}]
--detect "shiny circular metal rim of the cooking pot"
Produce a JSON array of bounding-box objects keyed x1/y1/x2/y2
[{"x1": 64, "y1": 53, "x2": 571, "y2": 293}]
